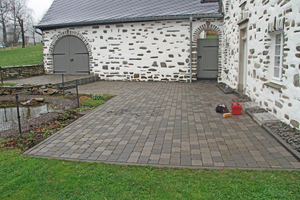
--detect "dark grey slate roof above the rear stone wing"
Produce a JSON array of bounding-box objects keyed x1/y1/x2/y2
[{"x1": 37, "y1": 0, "x2": 222, "y2": 30}]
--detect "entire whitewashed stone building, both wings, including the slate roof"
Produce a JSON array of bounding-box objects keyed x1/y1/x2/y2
[{"x1": 37, "y1": 0, "x2": 300, "y2": 128}]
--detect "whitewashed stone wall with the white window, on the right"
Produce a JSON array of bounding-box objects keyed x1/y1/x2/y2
[{"x1": 221, "y1": 0, "x2": 300, "y2": 128}]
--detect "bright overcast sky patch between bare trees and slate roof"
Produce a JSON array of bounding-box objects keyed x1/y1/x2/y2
[{"x1": 27, "y1": 0, "x2": 53, "y2": 20}]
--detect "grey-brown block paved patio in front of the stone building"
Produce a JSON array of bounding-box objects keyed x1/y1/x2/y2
[{"x1": 24, "y1": 81, "x2": 300, "y2": 170}]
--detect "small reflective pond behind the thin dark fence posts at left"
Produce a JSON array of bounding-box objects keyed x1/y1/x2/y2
[{"x1": 0, "y1": 101, "x2": 54, "y2": 131}]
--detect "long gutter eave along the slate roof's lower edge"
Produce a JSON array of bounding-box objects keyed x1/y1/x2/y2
[{"x1": 35, "y1": 13, "x2": 223, "y2": 30}]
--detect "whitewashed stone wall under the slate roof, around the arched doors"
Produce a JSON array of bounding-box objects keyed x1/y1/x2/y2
[{"x1": 43, "y1": 19, "x2": 223, "y2": 82}]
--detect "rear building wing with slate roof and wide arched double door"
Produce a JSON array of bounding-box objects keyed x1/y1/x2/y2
[{"x1": 37, "y1": 0, "x2": 223, "y2": 82}]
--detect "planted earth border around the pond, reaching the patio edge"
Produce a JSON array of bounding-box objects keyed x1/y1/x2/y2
[{"x1": 0, "y1": 93, "x2": 114, "y2": 151}]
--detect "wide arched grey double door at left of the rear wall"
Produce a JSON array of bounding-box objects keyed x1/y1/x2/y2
[{"x1": 53, "y1": 36, "x2": 89, "y2": 75}]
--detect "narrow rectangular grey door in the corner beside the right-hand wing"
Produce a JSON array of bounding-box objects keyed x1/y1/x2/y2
[{"x1": 197, "y1": 39, "x2": 219, "y2": 79}]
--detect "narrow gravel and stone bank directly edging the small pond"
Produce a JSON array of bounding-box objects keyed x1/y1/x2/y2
[{"x1": 0, "y1": 95, "x2": 77, "y2": 137}]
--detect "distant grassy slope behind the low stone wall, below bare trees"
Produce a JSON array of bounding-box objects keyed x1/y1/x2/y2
[{"x1": 0, "y1": 44, "x2": 43, "y2": 67}]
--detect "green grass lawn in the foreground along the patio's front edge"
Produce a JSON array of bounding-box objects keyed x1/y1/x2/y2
[{"x1": 0, "y1": 149, "x2": 300, "y2": 200}]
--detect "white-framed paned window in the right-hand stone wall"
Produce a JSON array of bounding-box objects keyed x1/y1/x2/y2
[{"x1": 273, "y1": 33, "x2": 283, "y2": 81}]
